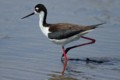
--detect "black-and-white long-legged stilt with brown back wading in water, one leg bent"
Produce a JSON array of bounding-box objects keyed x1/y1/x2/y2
[{"x1": 22, "y1": 4, "x2": 104, "y2": 74}]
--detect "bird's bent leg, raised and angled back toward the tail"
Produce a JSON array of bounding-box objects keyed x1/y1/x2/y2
[{"x1": 61, "y1": 36, "x2": 96, "y2": 59}]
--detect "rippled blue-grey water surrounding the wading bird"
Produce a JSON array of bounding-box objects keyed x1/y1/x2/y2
[{"x1": 0, "y1": 0, "x2": 120, "y2": 80}]
